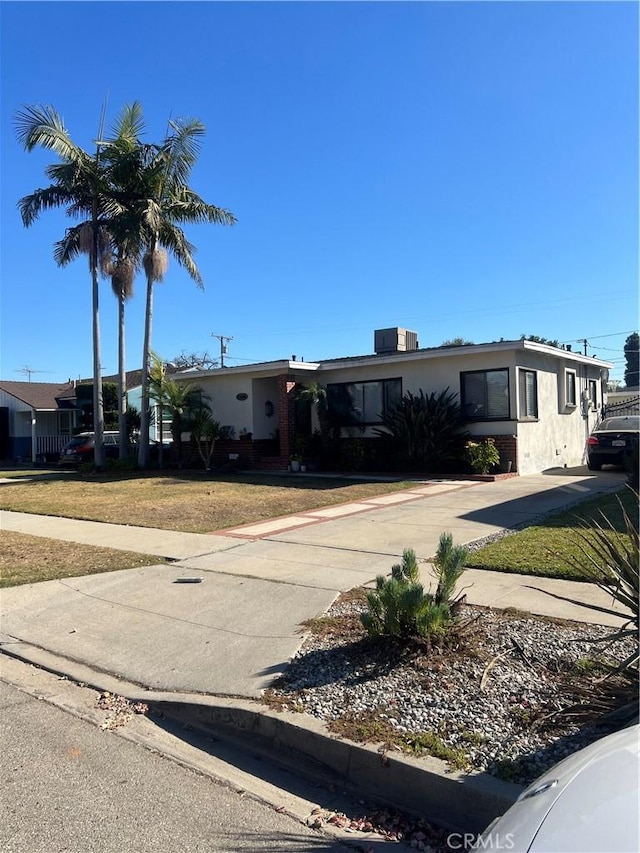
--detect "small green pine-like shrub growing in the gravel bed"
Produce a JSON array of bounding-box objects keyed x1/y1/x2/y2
[{"x1": 360, "y1": 533, "x2": 466, "y2": 640}]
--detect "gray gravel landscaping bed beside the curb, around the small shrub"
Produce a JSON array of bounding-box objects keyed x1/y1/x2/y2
[{"x1": 265, "y1": 594, "x2": 631, "y2": 784}]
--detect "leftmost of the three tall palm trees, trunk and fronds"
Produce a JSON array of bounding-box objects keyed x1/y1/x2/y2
[{"x1": 15, "y1": 105, "x2": 110, "y2": 469}]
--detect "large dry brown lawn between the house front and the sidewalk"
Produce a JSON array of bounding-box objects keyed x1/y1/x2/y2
[{"x1": 0, "y1": 472, "x2": 413, "y2": 533}]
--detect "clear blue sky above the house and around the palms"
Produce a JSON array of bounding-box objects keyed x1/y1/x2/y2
[{"x1": 0, "y1": 2, "x2": 639, "y2": 381}]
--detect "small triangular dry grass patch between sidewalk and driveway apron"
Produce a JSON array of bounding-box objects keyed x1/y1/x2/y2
[{"x1": 0, "y1": 530, "x2": 166, "y2": 587}]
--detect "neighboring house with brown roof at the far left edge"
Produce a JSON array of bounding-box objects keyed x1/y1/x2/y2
[{"x1": 0, "y1": 380, "x2": 77, "y2": 462}]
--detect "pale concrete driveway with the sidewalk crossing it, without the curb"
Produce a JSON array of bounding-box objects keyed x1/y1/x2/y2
[{"x1": 0, "y1": 472, "x2": 623, "y2": 698}]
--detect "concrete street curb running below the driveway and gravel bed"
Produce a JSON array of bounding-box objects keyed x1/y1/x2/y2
[{"x1": 0, "y1": 637, "x2": 522, "y2": 832}]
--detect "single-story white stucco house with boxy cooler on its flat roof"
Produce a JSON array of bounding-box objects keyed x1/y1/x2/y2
[{"x1": 175, "y1": 329, "x2": 612, "y2": 474}]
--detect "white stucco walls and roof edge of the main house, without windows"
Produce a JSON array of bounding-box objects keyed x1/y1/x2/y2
[{"x1": 172, "y1": 342, "x2": 607, "y2": 474}]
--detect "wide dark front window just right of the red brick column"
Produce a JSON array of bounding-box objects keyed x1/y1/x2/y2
[{"x1": 327, "y1": 379, "x2": 402, "y2": 426}]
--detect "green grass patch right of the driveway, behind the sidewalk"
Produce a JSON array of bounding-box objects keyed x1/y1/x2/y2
[{"x1": 467, "y1": 487, "x2": 638, "y2": 580}]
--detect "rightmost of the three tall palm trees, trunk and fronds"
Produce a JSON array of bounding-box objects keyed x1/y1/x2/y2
[{"x1": 107, "y1": 115, "x2": 236, "y2": 468}]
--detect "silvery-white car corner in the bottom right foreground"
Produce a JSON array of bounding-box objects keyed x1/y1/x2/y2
[{"x1": 472, "y1": 725, "x2": 640, "y2": 853}]
